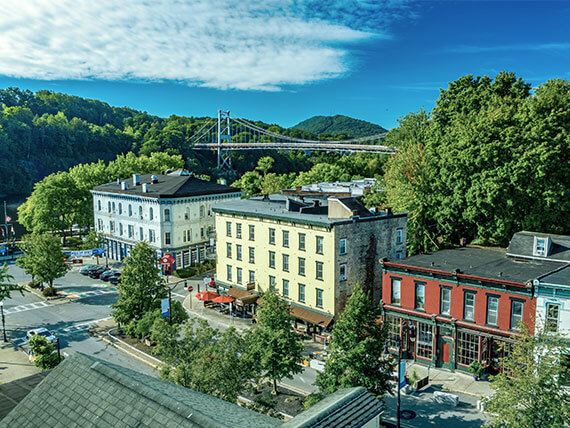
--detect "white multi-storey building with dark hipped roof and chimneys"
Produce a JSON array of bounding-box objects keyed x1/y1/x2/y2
[{"x1": 91, "y1": 170, "x2": 241, "y2": 269}]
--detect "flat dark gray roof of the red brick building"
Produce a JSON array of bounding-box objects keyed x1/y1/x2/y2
[{"x1": 391, "y1": 247, "x2": 560, "y2": 284}]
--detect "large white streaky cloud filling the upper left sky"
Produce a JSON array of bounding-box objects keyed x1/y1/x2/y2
[{"x1": 0, "y1": 0, "x2": 407, "y2": 90}]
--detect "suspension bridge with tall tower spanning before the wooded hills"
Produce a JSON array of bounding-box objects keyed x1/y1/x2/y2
[{"x1": 190, "y1": 110, "x2": 396, "y2": 168}]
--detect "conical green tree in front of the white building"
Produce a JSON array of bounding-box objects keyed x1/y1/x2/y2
[{"x1": 112, "y1": 242, "x2": 163, "y2": 325}]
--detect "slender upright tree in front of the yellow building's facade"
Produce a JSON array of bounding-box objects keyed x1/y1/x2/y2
[{"x1": 246, "y1": 290, "x2": 304, "y2": 394}]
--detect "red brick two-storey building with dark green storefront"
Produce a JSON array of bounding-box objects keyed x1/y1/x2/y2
[{"x1": 381, "y1": 247, "x2": 557, "y2": 373}]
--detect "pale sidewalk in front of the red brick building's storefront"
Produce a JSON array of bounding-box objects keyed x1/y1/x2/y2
[{"x1": 406, "y1": 361, "x2": 493, "y2": 398}]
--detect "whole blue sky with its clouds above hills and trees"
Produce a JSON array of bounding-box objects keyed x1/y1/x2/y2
[{"x1": 0, "y1": 0, "x2": 570, "y2": 128}]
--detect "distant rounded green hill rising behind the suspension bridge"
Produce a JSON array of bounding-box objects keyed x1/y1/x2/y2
[{"x1": 292, "y1": 115, "x2": 387, "y2": 137}]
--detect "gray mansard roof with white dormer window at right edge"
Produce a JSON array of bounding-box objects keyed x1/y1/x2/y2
[{"x1": 507, "y1": 231, "x2": 570, "y2": 263}]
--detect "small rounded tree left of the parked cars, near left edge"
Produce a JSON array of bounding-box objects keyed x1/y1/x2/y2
[{"x1": 17, "y1": 233, "x2": 70, "y2": 287}]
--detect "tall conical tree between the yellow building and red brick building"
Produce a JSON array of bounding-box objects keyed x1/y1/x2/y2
[{"x1": 316, "y1": 284, "x2": 394, "y2": 396}]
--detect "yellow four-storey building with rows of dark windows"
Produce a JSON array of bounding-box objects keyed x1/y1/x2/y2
[{"x1": 212, "y1": 195, "x2": 406, "y2": 331}]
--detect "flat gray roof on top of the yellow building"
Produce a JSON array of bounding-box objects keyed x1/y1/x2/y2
[{"x1": 212, "y1": 195, "x2": 406, "y2": 227}]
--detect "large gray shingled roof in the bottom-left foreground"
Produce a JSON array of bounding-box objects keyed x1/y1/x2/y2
[{"x1": 0, "y1": 354, "x2": 281, "y2": 428}]
